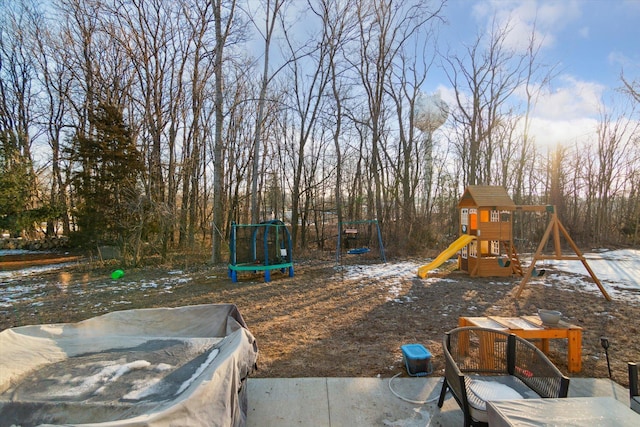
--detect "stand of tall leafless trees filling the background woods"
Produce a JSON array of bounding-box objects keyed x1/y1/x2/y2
[{"x1": 5, "y1": 0, "x2": 640, "y2": 262}]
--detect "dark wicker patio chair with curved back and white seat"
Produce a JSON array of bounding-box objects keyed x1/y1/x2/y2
[{"x1": 438, "y1": 326, "x2": 569, "y2": 426}]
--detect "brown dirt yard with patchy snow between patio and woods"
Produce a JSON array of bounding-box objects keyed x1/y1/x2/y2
[{"x1": 0, "y1": 252, "x2": 640, "y2": 386}]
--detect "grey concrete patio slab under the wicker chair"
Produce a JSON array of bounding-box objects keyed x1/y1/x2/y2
[{"x1": 247, "y1": 377, "x2": 629, "y2": 427}]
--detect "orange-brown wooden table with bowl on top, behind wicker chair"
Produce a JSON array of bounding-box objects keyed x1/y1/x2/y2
[{"x1": 458, "y1": 316, "x2": 582, "y2": 372}]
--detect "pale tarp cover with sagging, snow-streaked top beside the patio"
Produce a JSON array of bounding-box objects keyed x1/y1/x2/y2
[{"x1": 0, "y1": 304, "x2": 258, "y2": 427}]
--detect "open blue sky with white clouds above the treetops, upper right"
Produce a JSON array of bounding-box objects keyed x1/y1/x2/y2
[{"x1": 424, "y1": 0, "x2": 640, "y2": 145}]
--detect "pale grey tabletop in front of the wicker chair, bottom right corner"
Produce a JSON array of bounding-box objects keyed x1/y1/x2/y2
[{"x1": 487, "y1": 397, "x2": 640, "y2": 427}]
